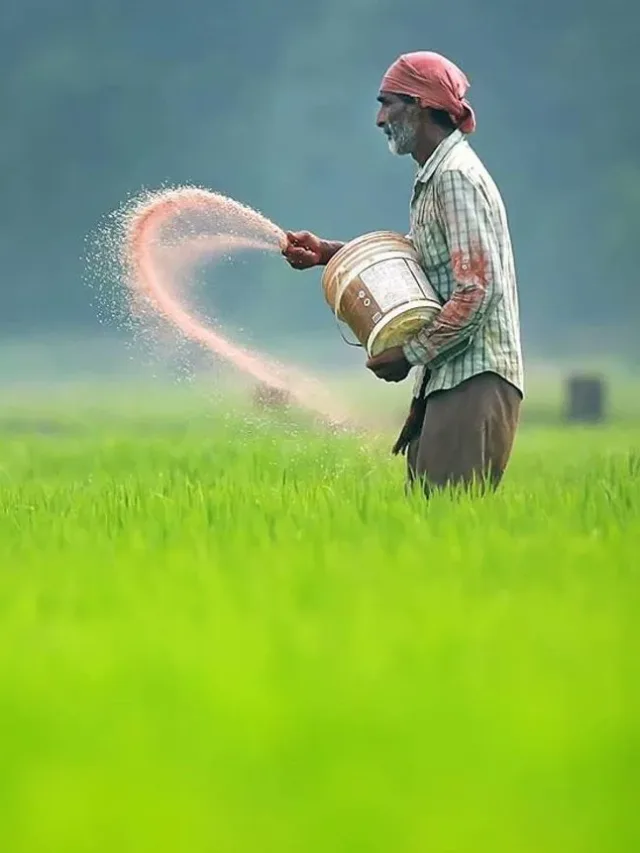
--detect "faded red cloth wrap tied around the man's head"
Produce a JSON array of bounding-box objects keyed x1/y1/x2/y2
[{"x1": 380, "y1": 51, "x2": 476, "y2": 133}]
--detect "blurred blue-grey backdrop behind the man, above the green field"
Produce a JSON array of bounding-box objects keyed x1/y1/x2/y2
[{"x1": 0, "y1": 0, "x2": 640, "y2": 358}]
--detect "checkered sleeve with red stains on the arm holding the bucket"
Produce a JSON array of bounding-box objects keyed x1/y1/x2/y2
[{"x1": 404, "y1": 170, "x2": 503, "y2": 368}]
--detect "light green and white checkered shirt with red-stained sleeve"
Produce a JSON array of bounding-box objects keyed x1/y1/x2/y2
[{"x1": 404, "y1": 130, "x2": 524, "y2": 396}]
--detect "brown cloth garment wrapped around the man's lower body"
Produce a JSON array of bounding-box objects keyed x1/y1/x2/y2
[{"x1": 407, "y1": 373, "x2": 522, "y2": 494}]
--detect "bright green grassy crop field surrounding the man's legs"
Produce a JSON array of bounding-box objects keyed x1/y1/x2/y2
[{"x1": 0, "y1": 398, "x2": 640, "y2": 853}]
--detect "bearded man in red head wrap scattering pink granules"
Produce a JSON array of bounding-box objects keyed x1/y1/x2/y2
[{"x1": 283, "y1": 52, "x2": 524, "y2": 493}]
